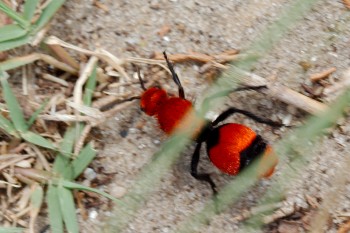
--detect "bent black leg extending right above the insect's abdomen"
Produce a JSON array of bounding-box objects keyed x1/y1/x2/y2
[{"x1": 212, "y1": 107, "x2": 284, "y2": 127}]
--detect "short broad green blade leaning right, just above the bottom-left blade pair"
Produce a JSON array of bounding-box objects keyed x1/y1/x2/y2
[{"x1": 72, "y1": 143, "x2": 96, "y2": 179}]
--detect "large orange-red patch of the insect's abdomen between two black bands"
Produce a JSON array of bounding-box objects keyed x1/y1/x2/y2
[{"x1": 207, "y1": 123, "x2": 256, "y2": 175}]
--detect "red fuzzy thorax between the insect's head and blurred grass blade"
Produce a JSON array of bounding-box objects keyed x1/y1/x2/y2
[{"x1": 157, "y1": 97, "x2": 193, "y2": 134}]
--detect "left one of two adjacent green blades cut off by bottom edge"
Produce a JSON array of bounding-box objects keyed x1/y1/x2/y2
[{"x1": 46, "y1": 185, "x2": 63, "y2": 233}]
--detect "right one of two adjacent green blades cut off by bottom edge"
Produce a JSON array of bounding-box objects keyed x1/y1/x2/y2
[{"x1": 57, "y1": 185, "x2": 79, "y2": 233}]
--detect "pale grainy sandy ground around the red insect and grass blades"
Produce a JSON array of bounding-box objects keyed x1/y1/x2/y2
[{"x1": 43, "y1": 0, "x2": 350, "y2": 232}]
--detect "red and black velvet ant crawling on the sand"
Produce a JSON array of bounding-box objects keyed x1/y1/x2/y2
[{"x1": 139, "y1": 52, "x2": 283, "y2": 194}]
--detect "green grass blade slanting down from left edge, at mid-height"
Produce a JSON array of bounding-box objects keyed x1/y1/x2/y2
[{"x1": 0, "y1": 71, "x2": 27, "y2": 132}]
